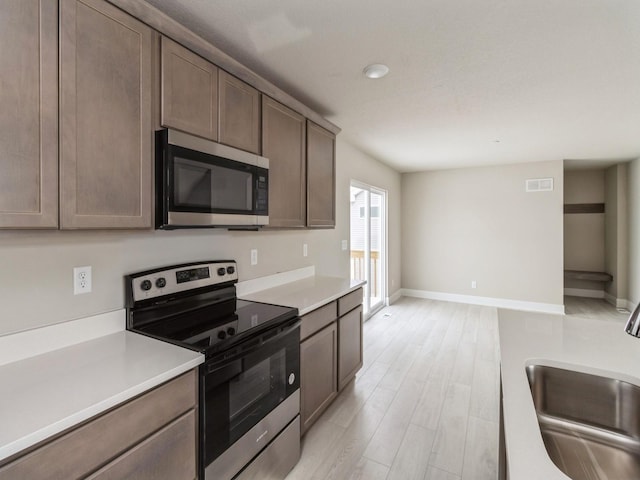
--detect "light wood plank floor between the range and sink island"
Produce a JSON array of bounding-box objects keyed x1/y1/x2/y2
[{"x1": 287, "y1": 297, "x2": 499, "y2": 480}]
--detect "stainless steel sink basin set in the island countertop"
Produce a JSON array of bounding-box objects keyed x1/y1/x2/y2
[{"x1": 526, "y1": 365, "x2": 640, "y2": 480}]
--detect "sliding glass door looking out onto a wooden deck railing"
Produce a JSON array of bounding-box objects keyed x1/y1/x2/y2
[{"x1": 351, "y1": 181, "x2": 386, "y2": 318}]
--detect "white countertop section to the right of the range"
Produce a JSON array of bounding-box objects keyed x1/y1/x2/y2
[{"x1": 238, "y1": 275, "x2": 365, "y2": 316}]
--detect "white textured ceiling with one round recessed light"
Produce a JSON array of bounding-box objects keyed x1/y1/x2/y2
[{"x1": 148, "y1": 0, "x2": 640, "y2": 172}]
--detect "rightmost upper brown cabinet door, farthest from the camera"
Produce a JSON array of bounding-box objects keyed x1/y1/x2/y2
[{"x1": 307, "y1": 120, "x2": 336, "y2": 227}]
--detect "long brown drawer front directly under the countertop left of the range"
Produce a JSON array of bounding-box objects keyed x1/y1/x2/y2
[{"x1": 0, "y1": 370, "x2": 197, "y2": 480}]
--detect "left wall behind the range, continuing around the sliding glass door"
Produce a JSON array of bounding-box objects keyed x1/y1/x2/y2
[{"x1": 0, "y1": 137, "x2": 400, "y2": 335}]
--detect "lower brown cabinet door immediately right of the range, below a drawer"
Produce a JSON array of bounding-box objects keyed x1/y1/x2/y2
[{"x1": 300, "y1": 322, "x2": 338, "y2": 433}]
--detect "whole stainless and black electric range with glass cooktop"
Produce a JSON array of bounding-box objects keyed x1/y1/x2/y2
[{"x1": 125, "y1": 260, "x2": 300, "y2": 480}]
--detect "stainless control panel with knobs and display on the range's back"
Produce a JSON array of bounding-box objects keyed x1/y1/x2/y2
[{"x1": 128, "y1": 260, "x2": 238, "y2": 302}]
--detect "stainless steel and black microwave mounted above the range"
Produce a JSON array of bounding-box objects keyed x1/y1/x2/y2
[{"x1": 156, "y1": 129, "x2": 269, "y2": 229}]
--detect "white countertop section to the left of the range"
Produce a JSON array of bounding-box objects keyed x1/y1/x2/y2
[{"x1": 0, "y1": 331, "x2": 204, "y2": 460}]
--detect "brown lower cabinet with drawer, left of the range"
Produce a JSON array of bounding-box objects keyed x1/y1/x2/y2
[{"x1": 0, "y1": 370, "x2": 198, "y2": 480}]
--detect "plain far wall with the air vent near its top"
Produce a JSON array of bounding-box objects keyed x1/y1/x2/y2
[{"x1": 402, "y1": 161, "x2": 563, "y2": 308}]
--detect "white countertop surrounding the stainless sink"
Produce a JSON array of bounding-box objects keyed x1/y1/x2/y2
[{"x1": 499, "y1": 310, "x2": 640, "y2": 480}]
